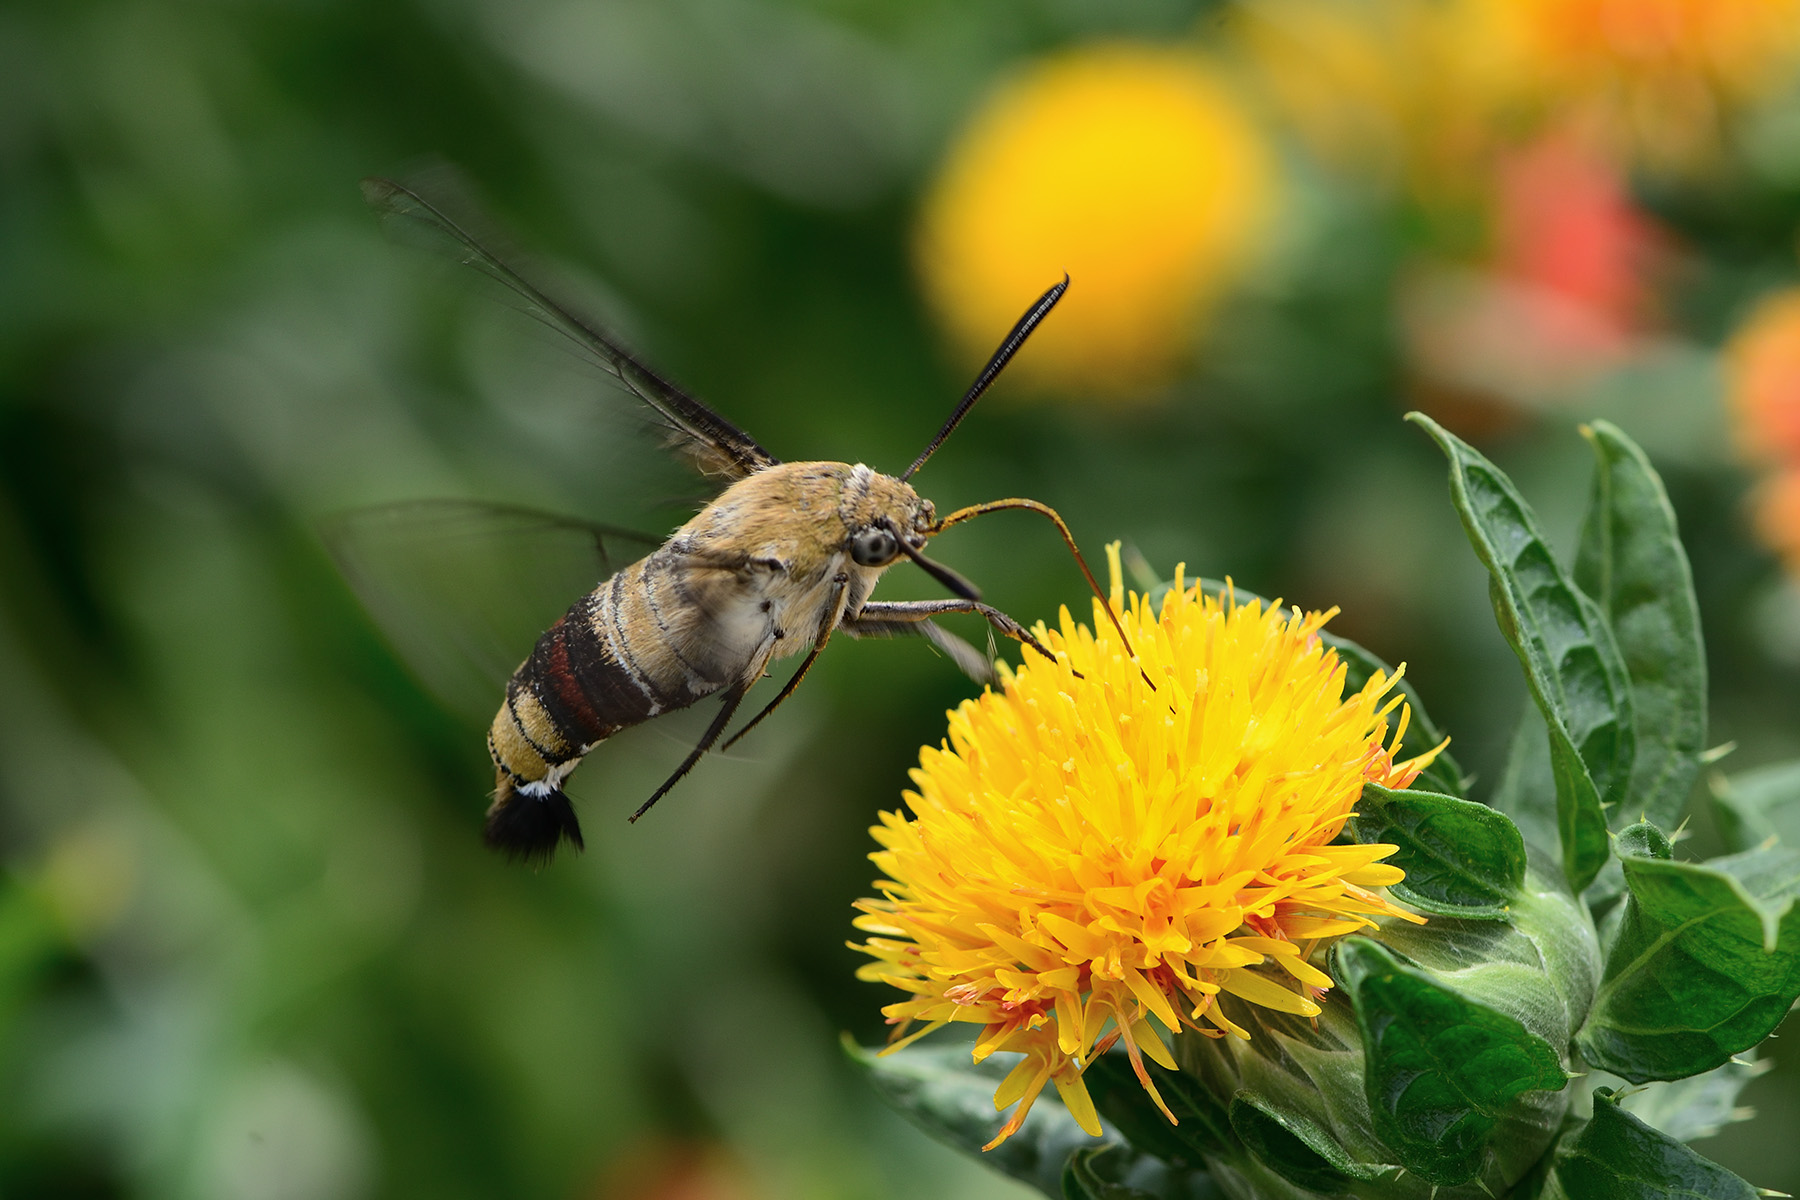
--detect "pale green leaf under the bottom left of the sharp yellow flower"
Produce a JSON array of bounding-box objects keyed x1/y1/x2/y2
[{"x1": 842, "y1": 1034, "x2": 1096, "y2": 1196}]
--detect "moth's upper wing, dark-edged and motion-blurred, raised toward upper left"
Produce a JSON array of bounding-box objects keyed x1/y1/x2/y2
[{"x1": 362, "y1": 178, "x2": 779, "y2": 479}]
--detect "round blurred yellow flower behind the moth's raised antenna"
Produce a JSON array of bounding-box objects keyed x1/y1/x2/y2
[{"x1": 918, "y1": 43, "x2": 1276, "y2": 398}]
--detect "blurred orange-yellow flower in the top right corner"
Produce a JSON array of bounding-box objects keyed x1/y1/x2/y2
[{"x1": 1483, "y1": 0, "x2": 1800, "y2": 167}]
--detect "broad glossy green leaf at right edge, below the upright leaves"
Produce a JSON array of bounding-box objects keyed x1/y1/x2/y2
[{"x1": 1575, "y1": 840, "x2": 1800, "y2": 1083}]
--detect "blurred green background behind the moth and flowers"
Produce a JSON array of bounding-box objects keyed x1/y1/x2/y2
[{"x1": 0, "y1": 0, "x2": 1800, "y2": 1200}]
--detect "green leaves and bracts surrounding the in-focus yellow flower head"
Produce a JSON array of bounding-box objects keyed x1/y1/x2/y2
[{"x1": 857, "y1": 414, "x2": 1800, "y2": 1200}]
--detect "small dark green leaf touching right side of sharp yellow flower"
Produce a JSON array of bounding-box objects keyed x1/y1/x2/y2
[{"x1": 1350, "y1": 783, "x2": 1525, "y2": 918}]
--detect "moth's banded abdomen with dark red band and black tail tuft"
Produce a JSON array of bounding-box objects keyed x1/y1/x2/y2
[{"x1": 486, "y1": 556, "x2": 718, "y2": 860}]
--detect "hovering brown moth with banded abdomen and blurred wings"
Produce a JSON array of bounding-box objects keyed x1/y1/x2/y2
[{"x1": 328, "y1": 180, "x2": 1123, "y2": 862}]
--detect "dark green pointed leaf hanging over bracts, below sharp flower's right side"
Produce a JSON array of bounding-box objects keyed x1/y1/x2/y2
[{"x1": 1336, "y1": 937, "x2": 1568, "y2": 1186}]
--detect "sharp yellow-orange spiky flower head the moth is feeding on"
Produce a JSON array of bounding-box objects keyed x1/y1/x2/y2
[{"x1": 857, "y1": 545, "x2": 1436, "y2": 1148}]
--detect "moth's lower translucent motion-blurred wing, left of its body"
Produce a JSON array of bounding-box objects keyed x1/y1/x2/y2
[{"x1": 322, "y1": 500, "x2": 661, "y2": 723}]
